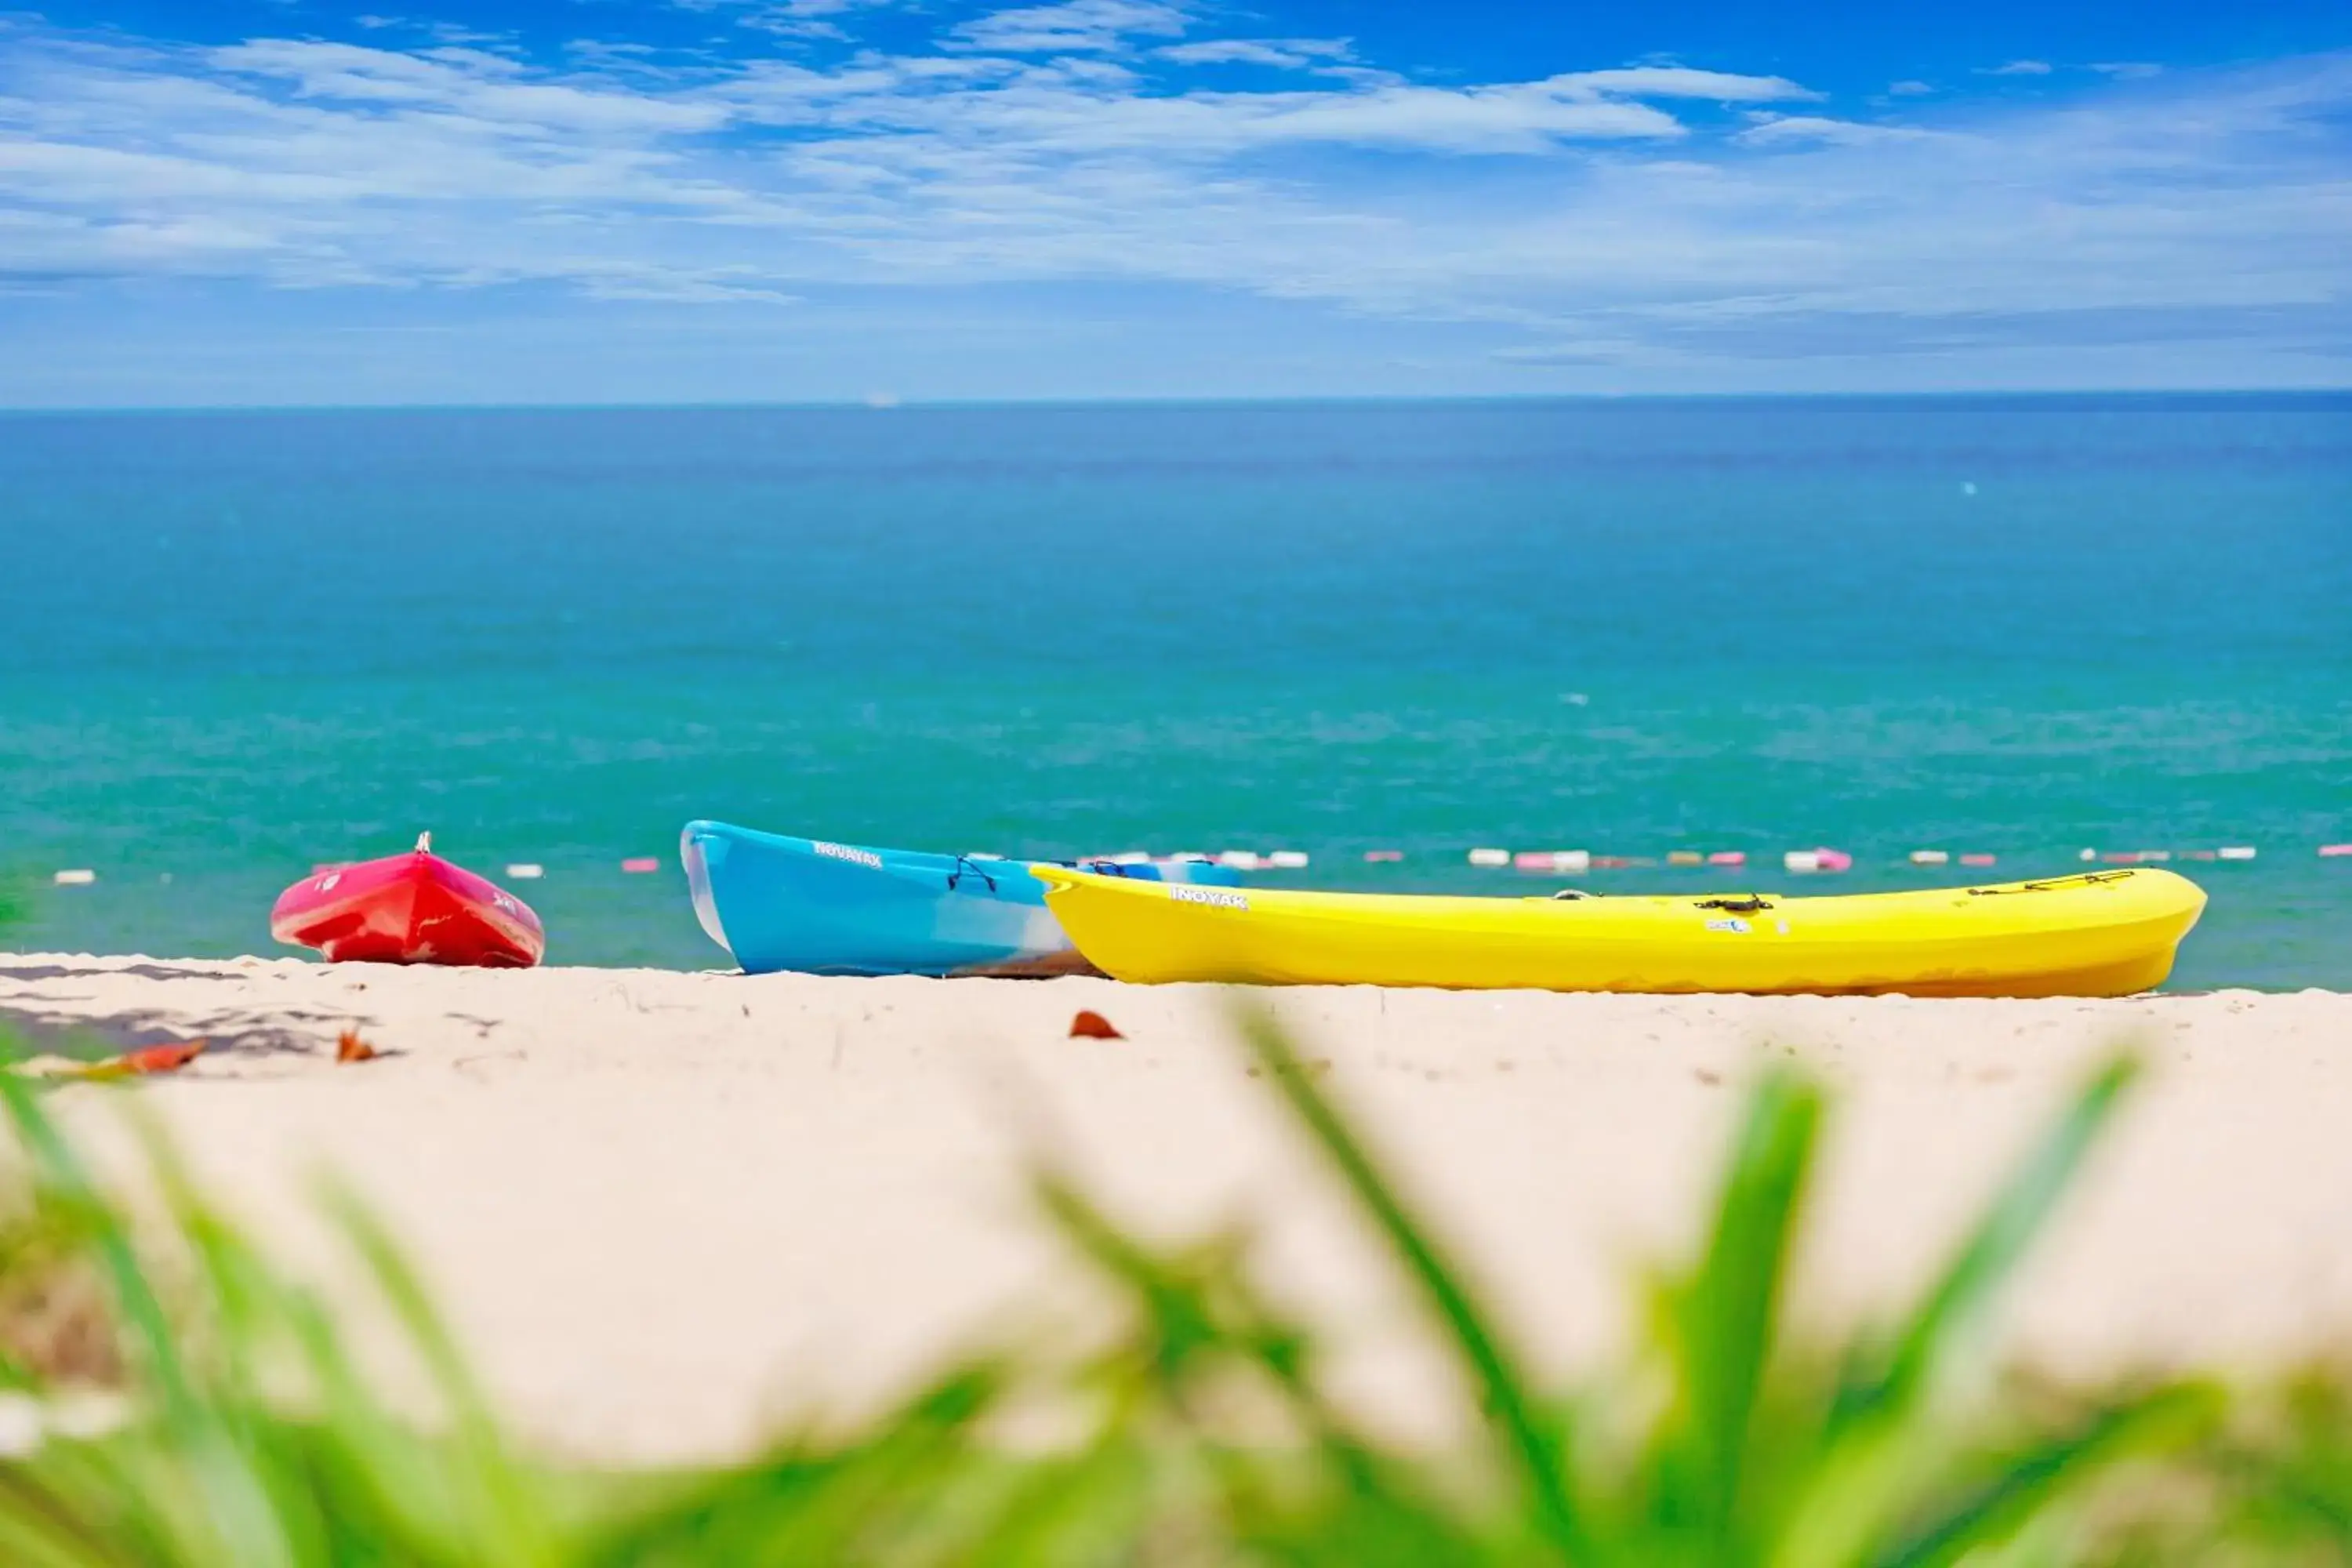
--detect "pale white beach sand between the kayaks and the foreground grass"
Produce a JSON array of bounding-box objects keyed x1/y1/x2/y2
[{"x1": 0, "y1": 954, "x2": 2352, "y2": 1457}]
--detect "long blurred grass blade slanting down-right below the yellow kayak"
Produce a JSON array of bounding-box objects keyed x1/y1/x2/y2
[{"x1": 1242, "y1": 1013, "x2": 1585, "y2": 1561}]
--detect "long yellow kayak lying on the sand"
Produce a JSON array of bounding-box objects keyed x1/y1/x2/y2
[{"x1": 1030, "y1": 865, "x2": 2204, "y2": 996}]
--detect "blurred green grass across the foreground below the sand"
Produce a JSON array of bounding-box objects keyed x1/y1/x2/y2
[{"x1": 0, "y1": 1020, "x2": 2352, "y2": 1568}]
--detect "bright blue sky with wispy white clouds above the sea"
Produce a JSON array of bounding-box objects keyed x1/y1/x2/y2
[{"x1": 0, "y1": 0, "x2": 2352, "y2": 407}]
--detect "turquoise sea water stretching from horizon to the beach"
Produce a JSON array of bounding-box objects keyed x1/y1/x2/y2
[{"x1": 0, "y1": 397, "x2": 2352, "y2": 987}]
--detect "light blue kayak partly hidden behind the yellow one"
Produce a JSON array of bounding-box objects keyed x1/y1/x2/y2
[{"x1": 677, "y1": 822, "x2": 1242, "y2": 975}]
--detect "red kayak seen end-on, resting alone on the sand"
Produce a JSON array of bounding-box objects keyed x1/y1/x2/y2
[{"x1": 270, "y1": 832, "x2": 548, "y2": 968}]
